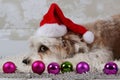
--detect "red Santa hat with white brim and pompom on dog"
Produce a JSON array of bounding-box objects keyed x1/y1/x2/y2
[{"x1": 35, "y1": 3, "x2": 94, "y2": 44}]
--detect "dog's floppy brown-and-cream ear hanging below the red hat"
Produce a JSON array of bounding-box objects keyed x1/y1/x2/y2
[{"x1": 62, "y1": 32, "x2": 89, "y2": 53}]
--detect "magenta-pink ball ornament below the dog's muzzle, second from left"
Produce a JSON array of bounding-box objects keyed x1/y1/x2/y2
[{"x1": 32, "y1": 61, "x2": 45, "y2": 74}]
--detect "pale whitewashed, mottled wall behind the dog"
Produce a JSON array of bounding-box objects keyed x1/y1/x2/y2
[{"x1": 0, "y1": 0, "x2": 120, "y2": 56}]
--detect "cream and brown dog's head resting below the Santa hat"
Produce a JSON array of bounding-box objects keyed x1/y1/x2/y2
[{"x1": 23, "y1": 32, "x2": 88, "y2": 65}]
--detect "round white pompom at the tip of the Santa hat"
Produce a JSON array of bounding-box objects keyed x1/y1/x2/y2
[{"x1": 83, "y1": 31, "x2": 94, "y2": 44}]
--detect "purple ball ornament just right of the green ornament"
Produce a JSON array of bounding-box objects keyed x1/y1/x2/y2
[{"x1": 76, "y1": 62, "x2": 90, "y2": 74}]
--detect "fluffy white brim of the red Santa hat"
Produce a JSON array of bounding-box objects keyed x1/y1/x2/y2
[{"x1": 35, "y1": 23, "x2": 67, "y2": 37}]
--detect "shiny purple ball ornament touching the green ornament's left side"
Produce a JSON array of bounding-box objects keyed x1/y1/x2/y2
[{"x1": 47, "y1": 62, "x2": 60, "y2": 74}]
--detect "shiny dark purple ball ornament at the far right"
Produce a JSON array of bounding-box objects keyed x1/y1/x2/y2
[{"x1": 103, "y1": 62, "x2": 118, "y2": 75}]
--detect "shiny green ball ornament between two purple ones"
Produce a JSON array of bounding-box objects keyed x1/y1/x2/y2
[{"x1": 61, "y1": 61, "x2": 73, "y2": 73}]
